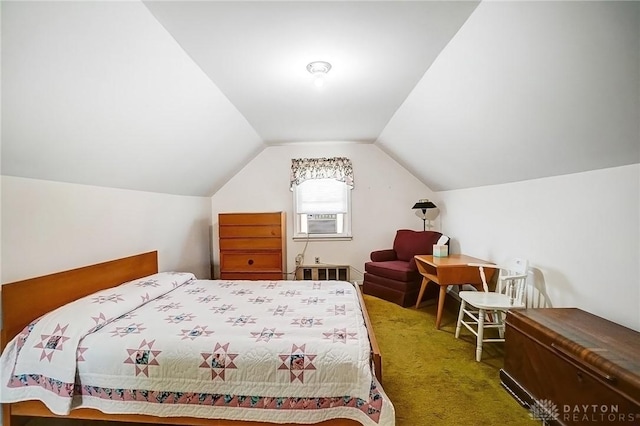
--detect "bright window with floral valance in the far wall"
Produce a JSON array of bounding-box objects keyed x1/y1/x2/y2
[{"x1": 291, "y1": 158, "x2": 353, "y2": 239}]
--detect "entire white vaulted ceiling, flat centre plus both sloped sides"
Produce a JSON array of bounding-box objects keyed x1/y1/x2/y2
[{"x1": 0, "y1": 0, "x2": 640, "y2": 196}]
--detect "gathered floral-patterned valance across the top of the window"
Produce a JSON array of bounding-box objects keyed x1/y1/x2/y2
[{"x1": 289, "y1": 157, "x2": 353, "y2": 190}]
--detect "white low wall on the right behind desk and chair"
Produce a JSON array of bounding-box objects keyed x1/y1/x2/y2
[{"x1": 437, "y1": 164, "x2": 640, "y2": 331}]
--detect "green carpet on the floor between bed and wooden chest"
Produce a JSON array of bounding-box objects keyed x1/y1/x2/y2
[{"x1": 364, "y1": 295, "x2": 536, "y2": 426}]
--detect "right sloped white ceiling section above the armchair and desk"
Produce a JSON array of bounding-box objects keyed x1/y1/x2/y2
[{"x1": 377, "y1": 1, "x2": 640, "y2": 191}]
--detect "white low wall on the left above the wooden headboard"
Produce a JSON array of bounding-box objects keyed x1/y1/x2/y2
[{"x1": 1, "y1": 176, "x2": 210, "y2": 283}]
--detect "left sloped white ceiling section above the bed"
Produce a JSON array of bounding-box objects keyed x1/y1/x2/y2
[{"x1": 2, "y1": 1, "x2": 264, "y2": 196}]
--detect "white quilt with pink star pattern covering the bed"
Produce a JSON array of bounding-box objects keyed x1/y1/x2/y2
[{"x1": 0, "y1": 273, "x2": 394, "y2": 425}]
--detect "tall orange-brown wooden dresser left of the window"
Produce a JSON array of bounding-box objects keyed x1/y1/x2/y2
[{"x1": 218, "y1": 212, "x2": 287, "y2": 280}]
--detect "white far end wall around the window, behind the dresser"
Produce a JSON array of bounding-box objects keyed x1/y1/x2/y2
[{"x1": 211, "y1": 143, "x2": 439, "y2": 280}]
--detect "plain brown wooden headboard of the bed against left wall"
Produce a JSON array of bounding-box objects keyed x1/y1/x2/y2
[{"x1": 0, "y1": 251, "x2": 158, "y2": 349}]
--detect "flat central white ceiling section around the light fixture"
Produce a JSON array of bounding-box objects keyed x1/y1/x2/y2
[{"x1": 145, "y1": 1, "x2": 478, "y2": 143}]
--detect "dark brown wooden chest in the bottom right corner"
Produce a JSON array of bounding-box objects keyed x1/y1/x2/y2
[{"x1": 500, "y1": 308, "x2": 640, "y2": 425}]
